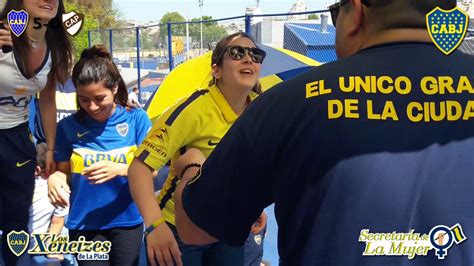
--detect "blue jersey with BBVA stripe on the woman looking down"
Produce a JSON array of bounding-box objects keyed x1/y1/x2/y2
[{"x1": 55, "y1": 105, "x2": 151, "y2": 230}]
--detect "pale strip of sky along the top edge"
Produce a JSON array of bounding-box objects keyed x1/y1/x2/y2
[{"x1": 113, "y1": 0, "x2": 335, "y2": 21}]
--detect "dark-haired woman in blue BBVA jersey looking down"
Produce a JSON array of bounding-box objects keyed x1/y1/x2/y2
[{"x1": 48, "y1": 46, "x2": 151, "y2": 265}]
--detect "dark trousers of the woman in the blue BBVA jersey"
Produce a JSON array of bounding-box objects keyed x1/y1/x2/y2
[{"x1": 69, "y1": 224, "x2": 143, "y2": 266}]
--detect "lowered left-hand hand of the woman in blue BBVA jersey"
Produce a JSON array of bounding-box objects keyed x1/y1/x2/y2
[{"x1": 48, "y1": 171, "x2": 71, "y2": 207}]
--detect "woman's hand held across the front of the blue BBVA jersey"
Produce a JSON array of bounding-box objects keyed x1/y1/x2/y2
[{"x1": 82, "y1": 161, "x2": 128, "y2": 185}]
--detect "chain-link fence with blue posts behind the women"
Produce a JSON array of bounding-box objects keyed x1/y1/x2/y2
[{"x1": 89, "y1": 10, "x2": 336, "y2": 103}]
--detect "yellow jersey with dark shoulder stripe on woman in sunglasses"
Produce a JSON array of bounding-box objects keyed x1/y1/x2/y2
[{"x1": 135, "y1": 86, "x2": 257, "y2": 224}]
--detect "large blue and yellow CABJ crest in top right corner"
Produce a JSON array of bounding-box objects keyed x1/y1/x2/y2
[{"x1": 426, "y1": 7, "x2": 469, "y2": 55}]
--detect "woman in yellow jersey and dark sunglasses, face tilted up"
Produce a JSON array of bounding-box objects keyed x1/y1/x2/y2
[{"x1": 128, "y1": 33, "x2": 265, "y2": 266}]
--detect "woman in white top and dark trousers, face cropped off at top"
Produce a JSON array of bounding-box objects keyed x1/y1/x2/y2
[{"x1": 0, "y1": 0, "x2": 72, "y2": 265}]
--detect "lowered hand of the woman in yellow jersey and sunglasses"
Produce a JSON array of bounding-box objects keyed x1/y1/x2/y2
[{"x1": 146, "y1": 223, "x2": 183, "y2": 266}]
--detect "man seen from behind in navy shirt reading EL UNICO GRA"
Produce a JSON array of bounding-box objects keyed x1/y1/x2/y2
[{"x1": 176, "y1": 0, "x2": 474, "y2": 266}]
